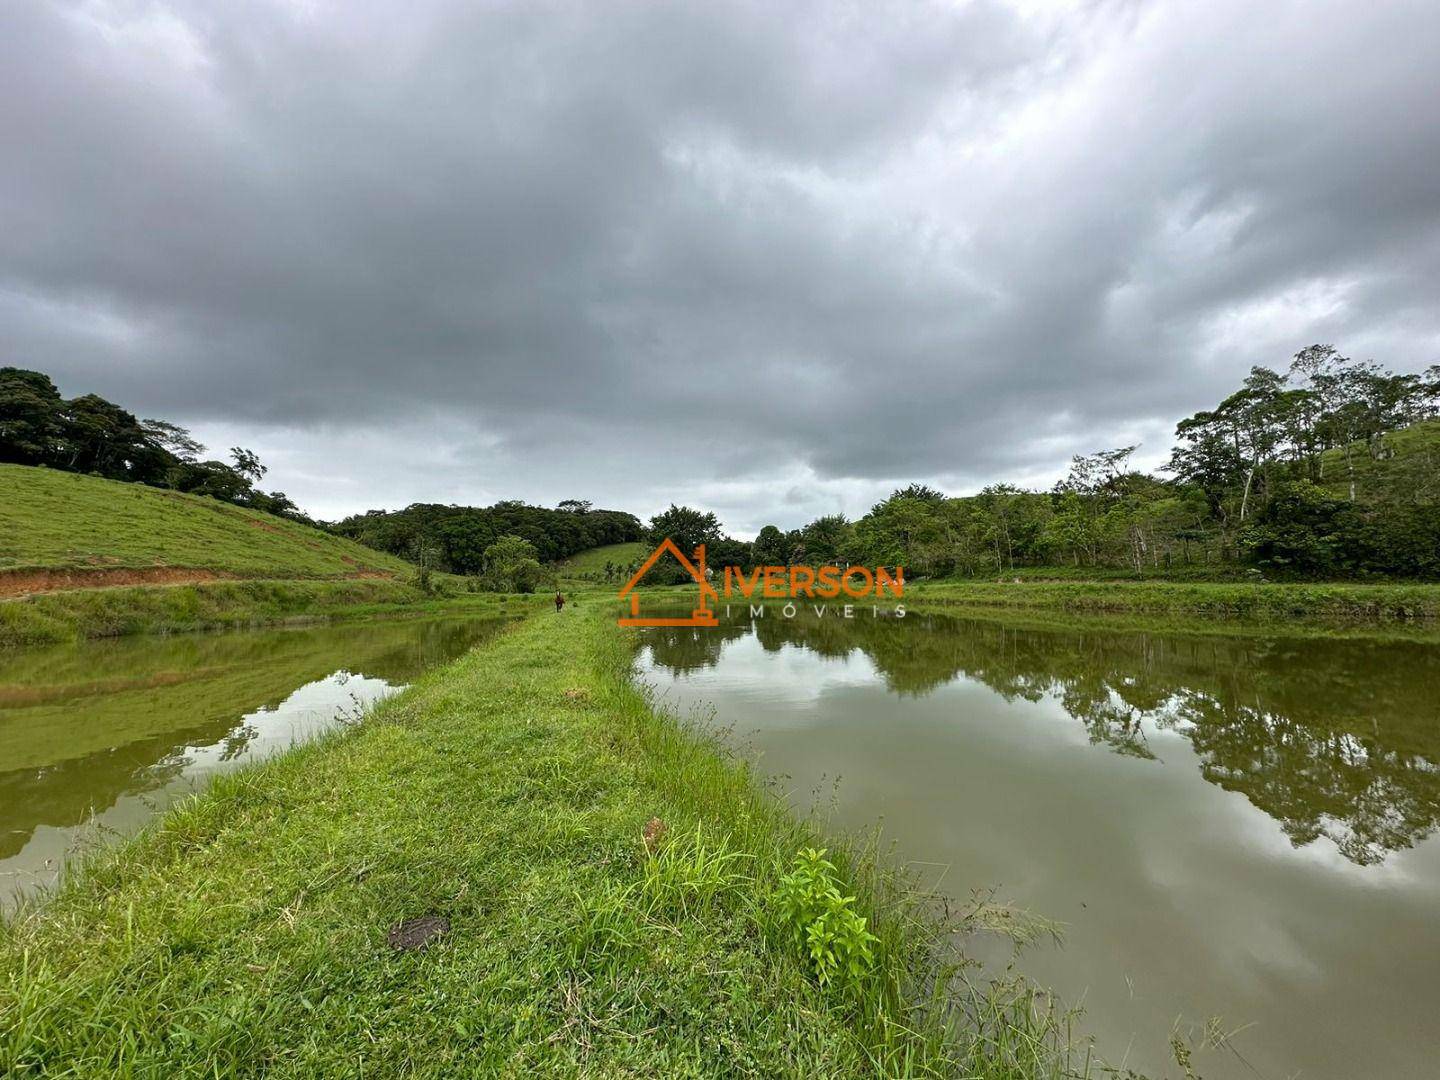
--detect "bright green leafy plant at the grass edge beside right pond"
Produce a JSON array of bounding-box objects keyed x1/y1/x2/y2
[{"x1": 776, "y1": 848, "x2": 880, "y2": 986}]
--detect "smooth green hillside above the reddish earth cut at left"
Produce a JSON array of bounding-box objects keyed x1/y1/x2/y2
[{"x1": 0, "y1": 465, "x2": 413, "y2": 588}]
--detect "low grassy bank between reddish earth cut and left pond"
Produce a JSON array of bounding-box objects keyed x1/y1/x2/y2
[{"x1": 0, "y1": 579, "x2": 537, "y2": 649}]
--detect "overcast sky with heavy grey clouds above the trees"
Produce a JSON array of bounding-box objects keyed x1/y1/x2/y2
[{"x1": 0, "y1": 0, "x2": 1440, "y2": 536}]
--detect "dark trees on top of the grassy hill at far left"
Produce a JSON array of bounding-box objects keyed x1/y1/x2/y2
[{"x1": 0, "y1": 367, "x2": 310, "y2": 523}]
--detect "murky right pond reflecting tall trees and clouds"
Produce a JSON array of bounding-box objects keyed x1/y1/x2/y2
[{"x1": 639, "y1": 606, "x2": 1440, "y2": 1080}]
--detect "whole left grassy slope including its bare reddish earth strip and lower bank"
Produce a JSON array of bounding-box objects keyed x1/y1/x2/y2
[{"x1": 0, "y1": 465, "x2": 498, "y2": 648}]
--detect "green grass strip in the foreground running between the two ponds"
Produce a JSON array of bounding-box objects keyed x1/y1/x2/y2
[{"x1": 0, "y1": 610, "x2": 1084, "y2": 1079}]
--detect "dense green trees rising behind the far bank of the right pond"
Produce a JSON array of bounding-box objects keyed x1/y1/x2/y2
[{"x1": 636, "y1": 346, "x2": 1440, "y2": 579}]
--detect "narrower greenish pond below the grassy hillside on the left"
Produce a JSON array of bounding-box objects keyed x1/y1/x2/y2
[{"x1": 0, "y1": 619, "x2": 501, "y2": 907}]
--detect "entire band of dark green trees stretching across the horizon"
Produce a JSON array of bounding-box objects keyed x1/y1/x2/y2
[{"x1": 0, "y1": 346, "x2": 1440, "y2": 589}]
